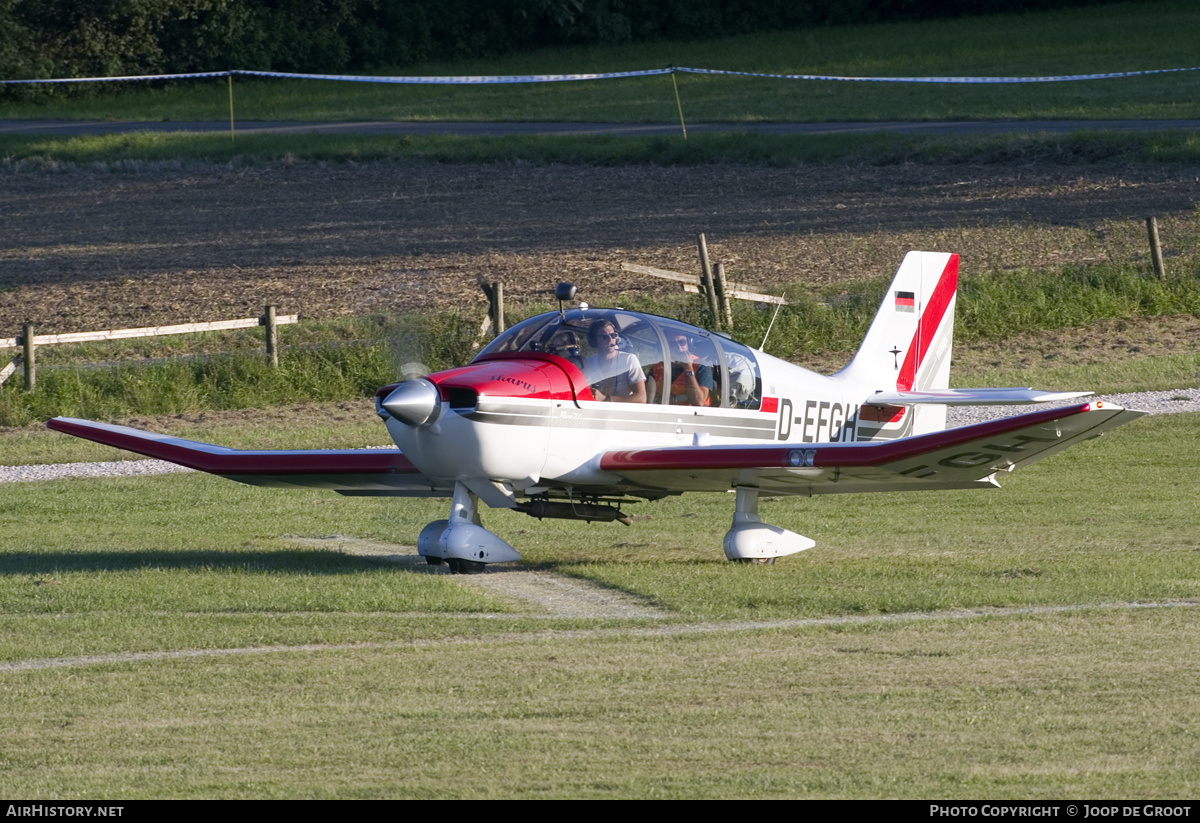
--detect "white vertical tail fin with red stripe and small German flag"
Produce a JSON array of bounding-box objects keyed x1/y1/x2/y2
[{"x1": 834, "y1": 252, "x2": 959, "y2": 434}]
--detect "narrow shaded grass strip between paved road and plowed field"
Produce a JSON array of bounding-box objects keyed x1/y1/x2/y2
[{"x1": 0, "y1": 131, "x2": 1200, "y2": 172}]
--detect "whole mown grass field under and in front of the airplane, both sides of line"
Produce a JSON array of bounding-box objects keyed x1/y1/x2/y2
[{"x1": 0, "y1": 415, "x2": 1200, "y2": 799}]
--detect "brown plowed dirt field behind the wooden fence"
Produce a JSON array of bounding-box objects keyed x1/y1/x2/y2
[{"x1": 0, "y1": 162, "x2": 1200, "y2": 336}]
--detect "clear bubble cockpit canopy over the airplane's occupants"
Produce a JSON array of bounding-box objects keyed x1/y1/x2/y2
[{"x1": 480, "y1": 308, "x2": 762, "y2": 409}]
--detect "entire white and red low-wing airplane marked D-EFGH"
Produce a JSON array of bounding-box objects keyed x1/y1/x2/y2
[{"x1": 48, "y1": 252, "x2": 1144, "y2": 572}]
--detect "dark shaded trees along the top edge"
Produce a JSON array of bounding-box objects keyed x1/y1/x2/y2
[{"x1": 0, "y1": 0, "x2": 1137, "y2": 96}]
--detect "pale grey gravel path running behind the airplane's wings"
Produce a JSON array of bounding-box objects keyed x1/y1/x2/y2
[{"x1": 0, "y1": 388, "x2": 1200, "y2": 483}]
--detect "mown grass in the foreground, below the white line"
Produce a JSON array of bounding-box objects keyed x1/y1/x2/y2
[{"x1": 0, "y1": 609, "x2": 1200, "y2": 800}]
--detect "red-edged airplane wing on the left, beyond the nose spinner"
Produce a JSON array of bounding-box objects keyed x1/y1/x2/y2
[{"x1": 46, "y1": 417, "x2": 450, "y2": 497}]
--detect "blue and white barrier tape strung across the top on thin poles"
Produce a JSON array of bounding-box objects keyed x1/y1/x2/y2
[{"x1": 7, "y1": 66, "x2": 1200, "y2": 85}]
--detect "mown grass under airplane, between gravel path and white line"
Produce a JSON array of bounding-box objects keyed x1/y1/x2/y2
[{"x1": 0, "y1": 414, "x2": 1200, "y2": 643}]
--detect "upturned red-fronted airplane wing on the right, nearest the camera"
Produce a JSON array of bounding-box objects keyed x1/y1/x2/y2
[{"x1": 600, "y1": 402, "x2": 1146, "y2": 495}]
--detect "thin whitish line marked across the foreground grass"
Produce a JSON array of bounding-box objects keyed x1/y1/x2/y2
[{"x1": 0, "y1": 600, "x2": 1200, "y2": 672}]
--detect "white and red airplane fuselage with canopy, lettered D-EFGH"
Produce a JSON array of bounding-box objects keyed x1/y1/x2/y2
[{"x1": 378, "y1": 308, "x2": 910, "y2": 494}]
